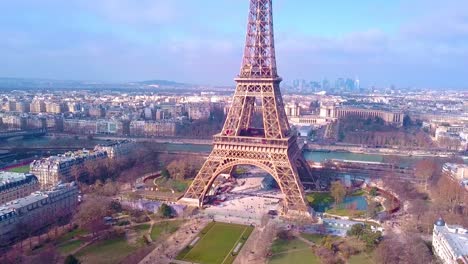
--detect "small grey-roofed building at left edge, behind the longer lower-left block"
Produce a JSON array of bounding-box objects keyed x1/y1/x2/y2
[{"x1": 0, "y1": 171, "x2": 39, "y2": 205}]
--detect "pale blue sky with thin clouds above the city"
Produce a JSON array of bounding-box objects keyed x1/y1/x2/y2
[{"x1": 0, "y1": 0, "x2": 468, "y2": 89}]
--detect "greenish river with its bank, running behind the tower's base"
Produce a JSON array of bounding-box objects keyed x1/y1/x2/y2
[{"x1": 0, "y1": 134, "x2": 468, "y2": 163}]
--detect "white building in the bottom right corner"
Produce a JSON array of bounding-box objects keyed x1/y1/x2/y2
[{"x1": 432, "y1": 218, "x2": 468, "y2": 264}]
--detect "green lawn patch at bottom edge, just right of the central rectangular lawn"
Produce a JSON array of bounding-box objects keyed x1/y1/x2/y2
[{"x1": 268, "y1": 239, "x2": 320, "y2": 264}]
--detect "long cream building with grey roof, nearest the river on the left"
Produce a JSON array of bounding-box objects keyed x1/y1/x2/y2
[{"x1": 30, "y1": 150, "x2": 107, "y2": 190}]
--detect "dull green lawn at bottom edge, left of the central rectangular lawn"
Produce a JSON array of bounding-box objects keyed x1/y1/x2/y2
[{"x1": 76, "y1": 236, "x2": 137, "y2": 264}]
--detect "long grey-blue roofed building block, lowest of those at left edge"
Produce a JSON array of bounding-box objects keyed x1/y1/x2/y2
[{"x1": 0, "y1": 183, "x2": 78, "y2": 245}]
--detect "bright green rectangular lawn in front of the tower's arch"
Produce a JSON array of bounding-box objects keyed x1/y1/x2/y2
[{"x1": 177, "y1": 222, "x2": 253, "y2": 264}]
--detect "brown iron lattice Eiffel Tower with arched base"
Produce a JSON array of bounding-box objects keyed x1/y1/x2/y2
[{"x1": 180, "y1": 0, "x2": 317, "y2": 218}]
